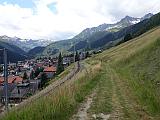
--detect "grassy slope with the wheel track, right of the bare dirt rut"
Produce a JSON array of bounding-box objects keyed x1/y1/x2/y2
[{"x1": 89, "y1": 28, "x2": 160, "y2": 120}]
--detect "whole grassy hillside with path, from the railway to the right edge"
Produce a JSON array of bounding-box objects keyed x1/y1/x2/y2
[{"x1": 2, "y1": 27, "x2": 160, "y2": 120}]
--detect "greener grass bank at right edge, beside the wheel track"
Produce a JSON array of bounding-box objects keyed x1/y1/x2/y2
[{"x1": 114, "y1": 38, "x2": 160, "y2": 116}]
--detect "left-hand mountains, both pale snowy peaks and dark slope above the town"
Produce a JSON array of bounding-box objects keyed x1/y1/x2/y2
[{"x1": 0, "y1": 35, "x2": 51, "y2": 63}]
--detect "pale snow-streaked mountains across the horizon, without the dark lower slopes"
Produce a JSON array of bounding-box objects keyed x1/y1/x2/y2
[{"x1": 0, "y1": 13, "x2": 153, "y2": 55}]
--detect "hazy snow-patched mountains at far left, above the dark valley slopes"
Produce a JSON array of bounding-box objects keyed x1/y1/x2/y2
[{"x1": 0, "y1": 35, "x2": 53, "y2": 52}]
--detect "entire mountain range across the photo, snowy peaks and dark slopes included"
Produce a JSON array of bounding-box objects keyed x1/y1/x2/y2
[{"x1": 0, "y1": 13, "x2": 157, "y2": 63}]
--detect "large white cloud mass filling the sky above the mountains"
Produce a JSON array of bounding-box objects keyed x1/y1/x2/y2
[{"x1": 0, "y1": 0, "x2": 160, "y2": 39}]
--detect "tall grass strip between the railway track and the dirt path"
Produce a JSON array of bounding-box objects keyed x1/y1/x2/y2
[{"x1": 1, "y1": 61, "x2": 100, "y2": 120}]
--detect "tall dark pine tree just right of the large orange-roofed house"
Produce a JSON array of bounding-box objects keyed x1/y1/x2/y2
[{"x1": 56, "y1": 53, "x2": 64, "y2": 74}]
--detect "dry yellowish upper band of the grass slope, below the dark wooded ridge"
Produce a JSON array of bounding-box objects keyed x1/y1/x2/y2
[{"x1": 98, "y1": 27, "x2": 160, "y2": 62}]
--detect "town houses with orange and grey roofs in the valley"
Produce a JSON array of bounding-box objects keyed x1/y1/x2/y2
[{"x1": 0, "y1": 54, "x2": 85, "y2": 110}]
